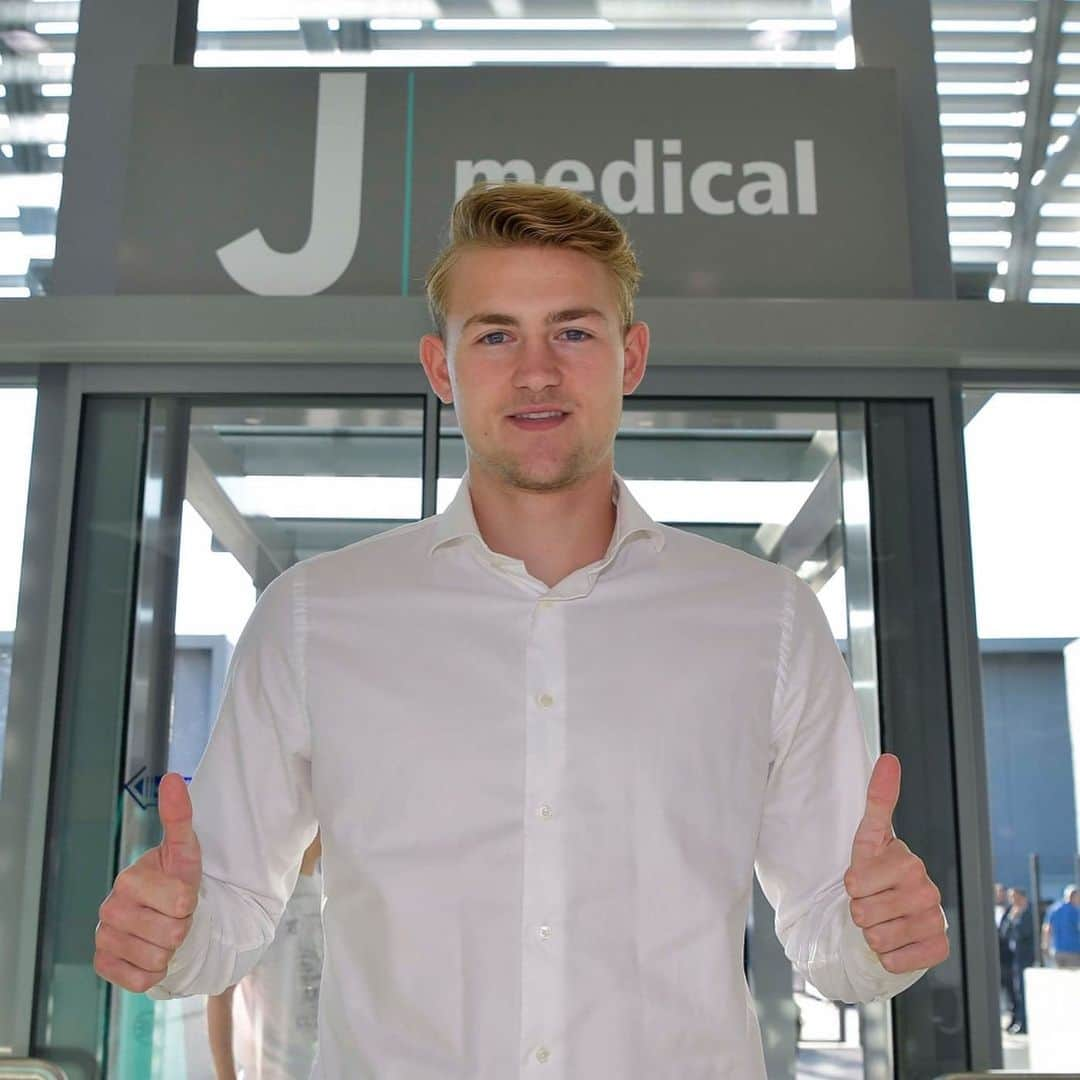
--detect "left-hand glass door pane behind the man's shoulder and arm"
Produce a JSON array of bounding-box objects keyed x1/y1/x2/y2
[{"x1": 109, "y1": 396, "x2": 423, "y2": 1080}]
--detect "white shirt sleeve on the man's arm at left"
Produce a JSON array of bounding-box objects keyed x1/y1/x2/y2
[{"x1": 146, "y1": 567, "x2": 319, "y2": 1001}]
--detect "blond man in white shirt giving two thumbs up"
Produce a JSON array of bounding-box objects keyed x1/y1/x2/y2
[{"x1": 95, "y1": 183, "x2": 948, "y2": 1080}]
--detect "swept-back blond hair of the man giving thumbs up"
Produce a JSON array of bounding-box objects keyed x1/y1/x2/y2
[{"x1": 424, "y1": 180, "x2": 642, "y2": 340}]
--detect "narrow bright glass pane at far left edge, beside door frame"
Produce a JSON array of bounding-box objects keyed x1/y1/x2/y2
[{"x1": 0, "y1": 388, "x2": 38, "y2": 792}]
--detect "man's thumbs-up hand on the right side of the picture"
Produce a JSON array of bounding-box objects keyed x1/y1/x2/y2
[{"x1": 843, "y1": 754, "x2": 949, "y2": 973}]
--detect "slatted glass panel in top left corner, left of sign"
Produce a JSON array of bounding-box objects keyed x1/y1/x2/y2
[{"x1": 0, "y1": 0, "x2": 79, "y2": 297}]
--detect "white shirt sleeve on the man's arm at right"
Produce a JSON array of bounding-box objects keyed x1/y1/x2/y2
[{"x1": 755, "y1": 569, "x2": 928, "y2": 1002}]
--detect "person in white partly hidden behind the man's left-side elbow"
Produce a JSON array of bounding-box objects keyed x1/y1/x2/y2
[{"x1": 206, "y1": 833, "x2": 323, "y2": 1080}]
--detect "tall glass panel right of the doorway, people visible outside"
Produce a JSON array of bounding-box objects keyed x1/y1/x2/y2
[{"x1": 963, "y1": 390, "x2": 1080, "y2": 1072}]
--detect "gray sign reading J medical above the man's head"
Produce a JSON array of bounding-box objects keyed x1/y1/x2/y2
[{"x1": 119, "y1": 66, "x2": 910, "y2": 298}]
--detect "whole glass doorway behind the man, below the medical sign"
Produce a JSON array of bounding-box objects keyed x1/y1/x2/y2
[{"x1": 37, "y1": 382, "x2": 963, "y2": 1080}]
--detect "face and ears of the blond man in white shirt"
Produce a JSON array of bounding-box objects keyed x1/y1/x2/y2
[{"x1": 420, "y1": 244, "x2": 649, "y2": 491}]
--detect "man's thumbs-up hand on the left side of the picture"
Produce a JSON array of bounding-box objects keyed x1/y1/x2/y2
[{"x1": 94, "y1": 772, "x2": 202, "y2": 994}]
